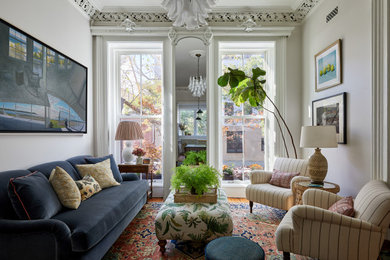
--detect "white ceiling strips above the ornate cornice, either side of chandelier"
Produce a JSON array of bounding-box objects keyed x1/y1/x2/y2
[{"x1": 90, "y1": 0, "x2": 303, "y2": 11}]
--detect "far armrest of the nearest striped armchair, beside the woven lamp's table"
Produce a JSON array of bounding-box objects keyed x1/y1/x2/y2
[{"x1": 302, "y1": 189, "x2": 342, "y2": 209}]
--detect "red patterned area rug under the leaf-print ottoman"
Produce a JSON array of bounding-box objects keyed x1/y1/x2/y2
[{"x1": 103, "y1": 202, "x2": 310, "y2": 260}]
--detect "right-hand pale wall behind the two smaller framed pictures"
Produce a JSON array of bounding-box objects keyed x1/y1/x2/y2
[{"x1": 301, "y1": 0, "x2": 371, "y2": 196}]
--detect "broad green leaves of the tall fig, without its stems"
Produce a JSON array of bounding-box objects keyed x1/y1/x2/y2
[{"x1": 218, "y1": 67, "x2": 266, "y2": 107}]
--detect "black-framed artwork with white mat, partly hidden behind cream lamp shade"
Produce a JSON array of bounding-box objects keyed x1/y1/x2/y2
[{"x1": 312, "y1": 92, "x2": 347, "y2": 144}]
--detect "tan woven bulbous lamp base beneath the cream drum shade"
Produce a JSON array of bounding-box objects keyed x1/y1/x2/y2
[{"x1": 308, "y1": 148, "x2": 328, "y2": 185}]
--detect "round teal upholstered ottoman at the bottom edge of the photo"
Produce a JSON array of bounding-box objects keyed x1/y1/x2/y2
[{"x1": 204, "y1": 237, "x2": 265, "y2": 260}]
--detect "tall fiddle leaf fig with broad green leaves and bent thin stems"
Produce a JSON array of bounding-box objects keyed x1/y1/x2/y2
[{"x1": 218, "y1": 67, "x2": 298, "y2": 158}]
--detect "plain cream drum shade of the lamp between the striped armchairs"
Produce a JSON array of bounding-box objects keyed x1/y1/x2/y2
[{"x1": 301, "y1": 125, "x2": 337, "y2": 148}]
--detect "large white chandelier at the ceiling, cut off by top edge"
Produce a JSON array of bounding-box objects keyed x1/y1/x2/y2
[{"x1": 161, "y1": 0, "x2": 216, "y2": 30}]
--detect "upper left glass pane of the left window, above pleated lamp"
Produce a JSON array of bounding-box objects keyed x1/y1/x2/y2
[{"x1": 120, "y1": 54, "x2": 141, "y2": 116}]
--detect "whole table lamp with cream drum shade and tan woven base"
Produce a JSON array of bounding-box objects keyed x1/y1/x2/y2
[{"x1": 300, "y1": 125, "x2": 337, "y2": 185}]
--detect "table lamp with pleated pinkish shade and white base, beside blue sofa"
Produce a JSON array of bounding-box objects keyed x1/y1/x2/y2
[{"x1": 115, "y1": 121, "x2": 144, "y2": 164}]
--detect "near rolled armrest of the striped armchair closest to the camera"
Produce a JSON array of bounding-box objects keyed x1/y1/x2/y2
[{"x1": 290, "y1": 205, "x2": 382, "y2": 232}]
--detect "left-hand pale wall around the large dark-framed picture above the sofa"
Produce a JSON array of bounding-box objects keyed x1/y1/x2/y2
[{"x1": 0, "y1": 0, "x2": 93, "y2": 171}]
